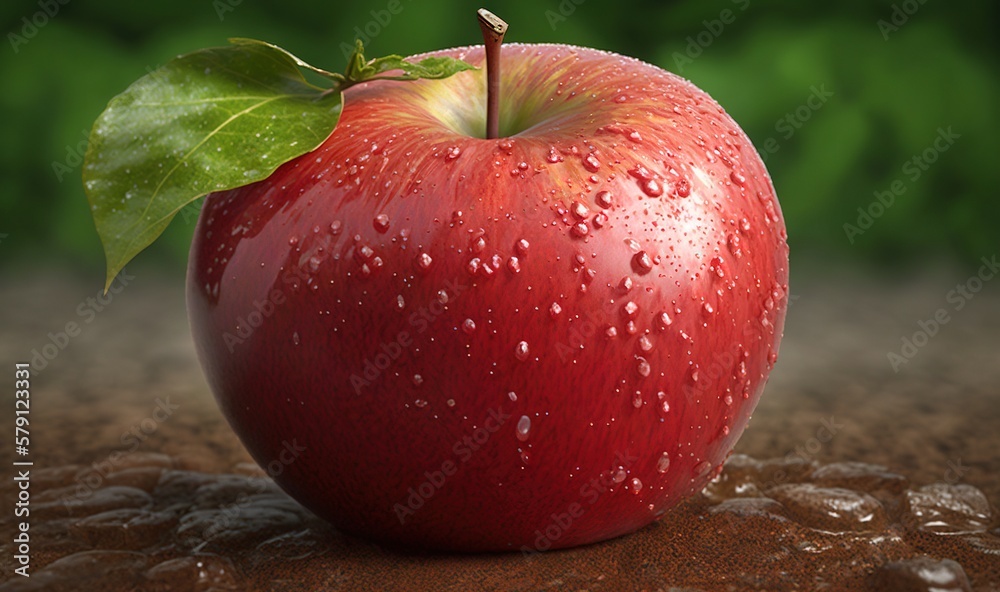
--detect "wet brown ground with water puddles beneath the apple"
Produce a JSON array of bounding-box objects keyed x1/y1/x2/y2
[{"x1": 0, "y1": 272, "x2": 1000, "y2": 591}]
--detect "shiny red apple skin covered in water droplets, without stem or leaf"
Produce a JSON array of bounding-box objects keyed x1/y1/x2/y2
[{"x1": 188, "y1": 44, "x2": 788, "y2": 551}]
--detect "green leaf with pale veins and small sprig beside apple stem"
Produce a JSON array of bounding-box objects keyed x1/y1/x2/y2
[{"x1": 83, "y1": 39, "x2": 472, "y2": 289}]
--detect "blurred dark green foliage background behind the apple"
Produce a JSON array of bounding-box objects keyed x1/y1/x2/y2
[{"x1": 0, "y1": 0, "x2": 1000, "y2": 274}]
